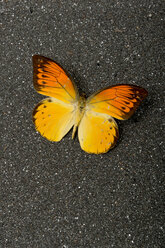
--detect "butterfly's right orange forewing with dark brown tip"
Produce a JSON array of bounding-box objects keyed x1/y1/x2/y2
[{"x1": 87, "y1": 84, "x2": 148, "y2": 120}]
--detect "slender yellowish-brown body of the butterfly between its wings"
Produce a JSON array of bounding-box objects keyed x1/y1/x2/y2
[{"x1": 72, "y1": 96, "x2": 86, "y2": 139}]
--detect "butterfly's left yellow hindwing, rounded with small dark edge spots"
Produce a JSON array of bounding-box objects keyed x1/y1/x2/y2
[{"x1": 33, "y1": 98, "x2": 75, "y2": 142}]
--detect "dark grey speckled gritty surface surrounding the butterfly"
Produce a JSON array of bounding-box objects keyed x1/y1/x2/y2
[{"x1": 0, "y1": 0, "x2": 165, "y2": 248}]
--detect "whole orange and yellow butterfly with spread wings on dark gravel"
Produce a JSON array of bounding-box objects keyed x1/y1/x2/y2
[{"x1": 33, "y1": 55, "x2": 148, "y2": 154}]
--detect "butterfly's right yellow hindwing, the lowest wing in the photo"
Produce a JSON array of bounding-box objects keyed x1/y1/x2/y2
[{"x1": 78, "y1": 111, "x2": 118, "y2": 154}]
